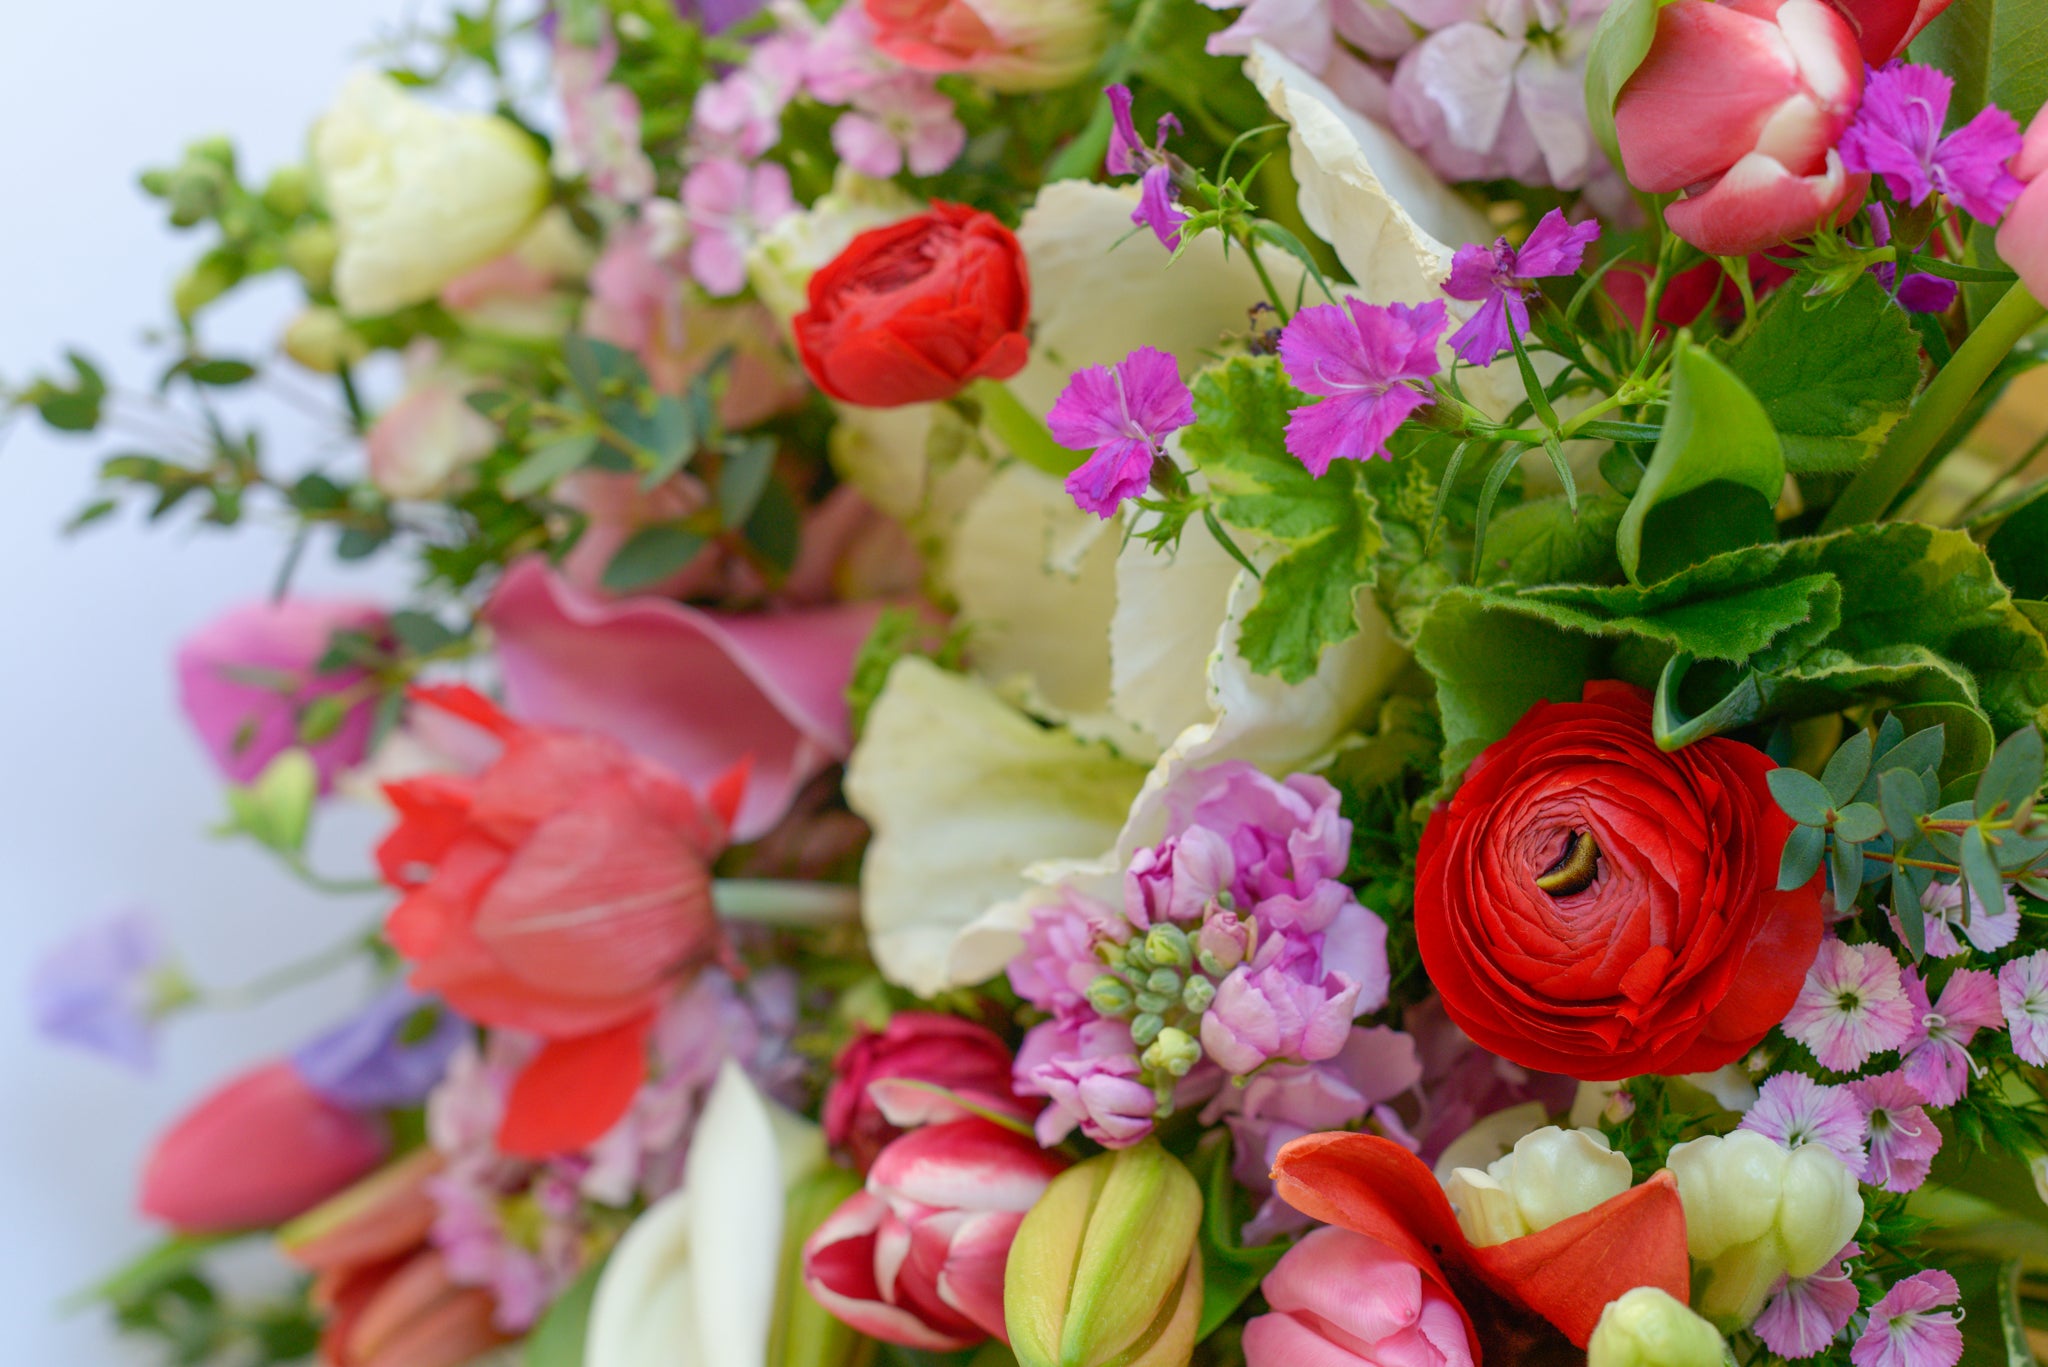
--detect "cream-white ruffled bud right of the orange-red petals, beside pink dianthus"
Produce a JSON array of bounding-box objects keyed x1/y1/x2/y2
[{"x1": 1667, "y1": 1129, "x2": 1864, "y2": 1326}]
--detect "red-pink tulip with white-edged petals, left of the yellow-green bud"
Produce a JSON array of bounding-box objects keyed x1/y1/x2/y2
[{"x1": 803, "y1": 1119, "x2": 1067, "y2": 1353}]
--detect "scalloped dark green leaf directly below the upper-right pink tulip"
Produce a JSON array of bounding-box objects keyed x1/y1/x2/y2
[{"x1": 1726, "y1": 275, "x2": 1921, "y2": 473}]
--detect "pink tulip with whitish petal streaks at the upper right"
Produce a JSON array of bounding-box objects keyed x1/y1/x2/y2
[{"x1": 1614, "y1": 0, "x2": 1868, "y2": 256}]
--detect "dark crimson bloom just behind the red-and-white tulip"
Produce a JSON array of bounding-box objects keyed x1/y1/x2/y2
[{"x1": 823, "y1": 1010, "x2": 1036, "y2": 1170}]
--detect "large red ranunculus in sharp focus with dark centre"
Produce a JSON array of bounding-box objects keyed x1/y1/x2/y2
[{"x1": 1415, "y1": 680, "x2": 1821, "y2": 1080}]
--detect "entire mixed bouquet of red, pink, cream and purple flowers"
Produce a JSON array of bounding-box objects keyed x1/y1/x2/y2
[{"x1": 19, "y1": 0, "x2": 2048, "y2": 1367}]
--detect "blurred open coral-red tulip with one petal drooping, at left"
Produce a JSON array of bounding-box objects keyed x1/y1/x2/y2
[{"x1": 377, "y1": 689, "x2": 745, "y2": 1158}]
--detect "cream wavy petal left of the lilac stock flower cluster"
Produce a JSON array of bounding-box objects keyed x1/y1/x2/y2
[{"x1": 846, "y1": 658, "x2": 1143, "y2": 996}]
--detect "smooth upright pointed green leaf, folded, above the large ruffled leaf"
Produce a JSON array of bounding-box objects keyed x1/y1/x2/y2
[{"x1": 1616, "y1": 340, "x2": 1786, "y2": 584}]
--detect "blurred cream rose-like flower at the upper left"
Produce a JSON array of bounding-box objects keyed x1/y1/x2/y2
[{"x1": 313, "y1": 72, "x2": 547, "y2": 316}]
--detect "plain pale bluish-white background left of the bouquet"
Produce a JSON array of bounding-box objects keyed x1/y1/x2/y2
[{"x1": 0, "y1": 0, "x2": 440, "y2": 1367}]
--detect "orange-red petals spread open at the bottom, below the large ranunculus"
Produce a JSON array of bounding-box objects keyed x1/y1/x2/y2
[{"x1": 1245, "y1": 1133, "x2": 1692, "y2": 1367}]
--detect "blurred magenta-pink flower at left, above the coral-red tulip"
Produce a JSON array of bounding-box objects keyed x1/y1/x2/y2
[{"x1": 176, "y1": 598, "x2": 385, "y2": 789}]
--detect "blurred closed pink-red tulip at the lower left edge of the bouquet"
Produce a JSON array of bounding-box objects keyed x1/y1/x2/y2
[{"x1": 141, "y1": 1062, "x2": 389, "y2": 1234}]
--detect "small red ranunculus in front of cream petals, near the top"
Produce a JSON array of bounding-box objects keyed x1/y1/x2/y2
[{"x1": 797, "y1": 203, "x2": 1030, "y2": 408}]
